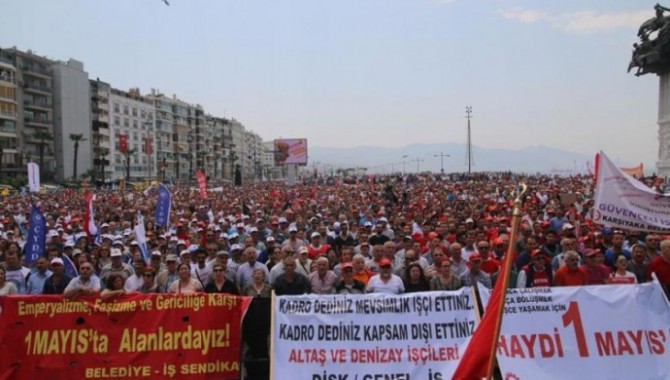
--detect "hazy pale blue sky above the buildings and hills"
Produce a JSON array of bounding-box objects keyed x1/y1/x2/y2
[{"x1": 0, "y1": 0, "x2": 658, "y2": 167}]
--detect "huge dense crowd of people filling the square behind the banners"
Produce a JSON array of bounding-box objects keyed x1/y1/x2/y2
[{"x1": 0, "y1": 173, "x2": 670, "y2": 299}]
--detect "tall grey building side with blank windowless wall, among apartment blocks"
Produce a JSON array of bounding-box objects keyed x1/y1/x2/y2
[{"x1": 52, "y1": 59, "x2": 93, "y2": 181}]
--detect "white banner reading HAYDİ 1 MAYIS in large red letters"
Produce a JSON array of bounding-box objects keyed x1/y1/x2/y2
[{"x1": 479, "y1": 283, "x2": 670, "y2": 380}]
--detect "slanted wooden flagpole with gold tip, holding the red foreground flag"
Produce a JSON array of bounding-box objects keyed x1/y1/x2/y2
[{"x1": 487, "y1": 183, "x2": 528, "y2": 380}]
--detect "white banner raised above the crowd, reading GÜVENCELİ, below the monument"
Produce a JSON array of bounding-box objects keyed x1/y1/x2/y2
[{"x1": 593, "y1": 152, "x2": 670, "y2": 231}]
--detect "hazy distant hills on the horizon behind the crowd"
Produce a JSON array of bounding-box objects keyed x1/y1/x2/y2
[{"x1": 309, "y1": 143, "x2": 600, "y2": 175}]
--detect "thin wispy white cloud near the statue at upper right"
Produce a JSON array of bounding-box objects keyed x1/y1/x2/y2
[{"x1": 499, "y1": 8, "x2": 653, "y2": 33}]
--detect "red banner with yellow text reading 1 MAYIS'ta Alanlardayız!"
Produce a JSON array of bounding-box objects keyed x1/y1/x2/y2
[{"x1": 0, "y1": 293, "x2": 251, "y2": 380}]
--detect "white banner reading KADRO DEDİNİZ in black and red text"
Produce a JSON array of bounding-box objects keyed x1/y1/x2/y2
[{"x1": 271, "y1": 288, "x2": 484, "y2": 380}]
